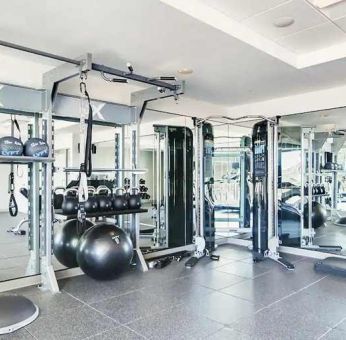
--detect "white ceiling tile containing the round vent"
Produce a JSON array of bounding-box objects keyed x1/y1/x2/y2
[{"x1": 243, "y1": 0, "x2": 327, "y2": 40}]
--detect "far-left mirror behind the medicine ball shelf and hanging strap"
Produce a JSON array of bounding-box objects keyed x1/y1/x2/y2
[{"x1": 0, "y1": 114, "x2": 41, "y2": 281}]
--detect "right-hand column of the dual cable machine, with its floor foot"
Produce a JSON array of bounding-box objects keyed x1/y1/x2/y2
[{"x1": 252, "y1": 118, "x2": 294, "y2": 270}]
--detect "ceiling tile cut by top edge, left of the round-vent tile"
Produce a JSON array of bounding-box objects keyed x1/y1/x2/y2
[{"x1": 200, "y1": 0, "x2": 290, "y2": 21}]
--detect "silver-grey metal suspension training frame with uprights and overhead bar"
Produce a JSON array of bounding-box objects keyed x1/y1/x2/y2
[{"x1": 0, "y1": 41, "x2": 184, "y2": 293}]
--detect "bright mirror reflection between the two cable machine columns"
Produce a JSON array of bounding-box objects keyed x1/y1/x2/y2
[{"x1": 209, "y1": 122, "x2": 252, "y2": 242}]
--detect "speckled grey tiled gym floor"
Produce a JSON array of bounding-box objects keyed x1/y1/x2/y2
[{"x1": 0, "y1": 246, "x2": 346, "y2": 340}]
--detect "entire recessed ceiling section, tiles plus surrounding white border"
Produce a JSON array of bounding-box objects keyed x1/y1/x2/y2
[{"x1": 161, "y1": 0, "x2": 346, "y2": 68}]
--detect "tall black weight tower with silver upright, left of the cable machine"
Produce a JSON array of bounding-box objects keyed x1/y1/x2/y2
[{"x1": 153, "y1": 125, "x2": 193, "y2": 251}]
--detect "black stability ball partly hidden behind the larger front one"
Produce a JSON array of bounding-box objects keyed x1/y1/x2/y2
[{"x1": 54, "y1": 219, "x2": 94, "y2": 268}]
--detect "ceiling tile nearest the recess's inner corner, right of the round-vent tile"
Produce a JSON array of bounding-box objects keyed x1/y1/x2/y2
[{"x1": 277, "y1": 23, "x2": 346, "y2": 53}]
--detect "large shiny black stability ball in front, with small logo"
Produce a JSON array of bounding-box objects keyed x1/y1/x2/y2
[{"x1": 77, "y1": 222, "x2": 133, "y2": 280}]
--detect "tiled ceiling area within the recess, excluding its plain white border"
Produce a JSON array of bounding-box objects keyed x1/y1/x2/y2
[{"x1": 200, "y1": 0, "x2": 346, "y2": 53}]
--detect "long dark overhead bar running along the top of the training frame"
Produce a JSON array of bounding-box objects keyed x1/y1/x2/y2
[{"x1": 0, "y1": 40, "x2": 179, "y2": 91}]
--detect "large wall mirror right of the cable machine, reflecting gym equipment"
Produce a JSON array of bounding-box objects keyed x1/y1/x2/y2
[{"x1": 279, "y1": 108, "x2": 346, "y2": 254}]
